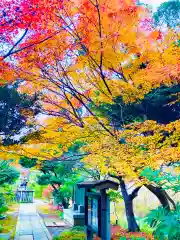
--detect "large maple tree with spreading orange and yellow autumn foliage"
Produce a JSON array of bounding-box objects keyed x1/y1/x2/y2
[{"x1": 1, "y1": 0, "x2": 179, "y2": 230}]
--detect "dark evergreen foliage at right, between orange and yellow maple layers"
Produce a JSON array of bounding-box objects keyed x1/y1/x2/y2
[{"x1": 96, "y1": 84, "x2": 180, "y2": 128}]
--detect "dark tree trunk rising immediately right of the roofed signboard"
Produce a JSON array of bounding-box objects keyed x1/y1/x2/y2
[{"x1": 120, "y1": 179, "x2": 140, "y2": 232}]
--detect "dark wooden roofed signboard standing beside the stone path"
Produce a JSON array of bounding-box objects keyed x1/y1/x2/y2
[{"x1": 77, "y1": 179, "x2": 119, "y2": 240}]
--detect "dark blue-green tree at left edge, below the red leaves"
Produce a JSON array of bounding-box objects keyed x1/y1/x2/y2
[{"x1": 0, "y1": 85, "x2": 39, "y2": 145}]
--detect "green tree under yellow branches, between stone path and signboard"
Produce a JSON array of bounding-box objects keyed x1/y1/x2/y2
[{"x1": 19, "y1": 141, "x2": 83, "y2": 208}]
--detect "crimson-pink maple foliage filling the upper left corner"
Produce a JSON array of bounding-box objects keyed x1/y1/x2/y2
[{"x1": 0, "y1": 0, "x2": 62, "y2": 59}]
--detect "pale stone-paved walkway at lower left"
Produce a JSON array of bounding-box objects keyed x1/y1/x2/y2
[{"x1": 14, "y1": 203, "x2": 52, "y2": 240}]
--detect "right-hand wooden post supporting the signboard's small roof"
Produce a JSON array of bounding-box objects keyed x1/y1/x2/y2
[{"x1": 100, "y1": 189, "x2": 111, "y2": 240}]
